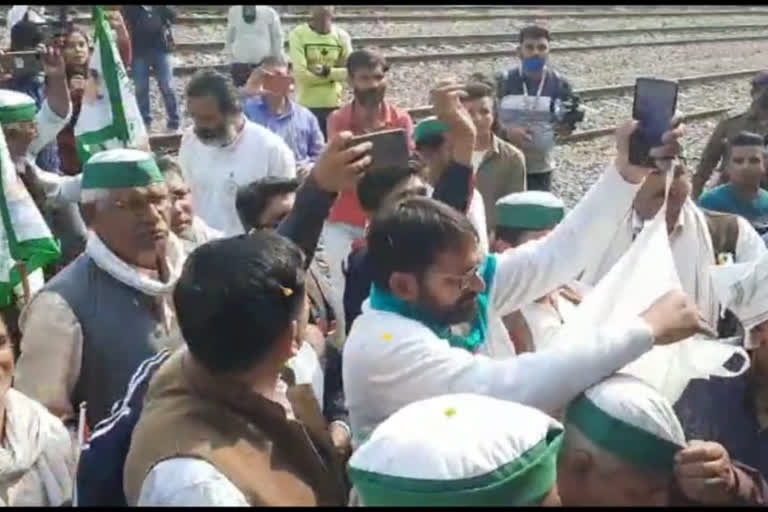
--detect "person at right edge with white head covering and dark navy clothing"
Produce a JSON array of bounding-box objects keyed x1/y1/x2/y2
[{"x1": 675, "y1": 255, "x2": 768, "y2": 482}]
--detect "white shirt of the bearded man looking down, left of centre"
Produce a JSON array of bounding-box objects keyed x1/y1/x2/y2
[{"x1": 179, "y1": 120, "x2": 296, "y2": 236}]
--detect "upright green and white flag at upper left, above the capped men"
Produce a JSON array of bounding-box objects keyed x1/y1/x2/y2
[{"x1": 75, "y1": 7, "x2": 149, "y2": 162}]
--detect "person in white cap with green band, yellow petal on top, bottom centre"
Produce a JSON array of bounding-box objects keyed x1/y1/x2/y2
[{"x1": 349, "y1": 394, "x2": 563, "y2": 507}]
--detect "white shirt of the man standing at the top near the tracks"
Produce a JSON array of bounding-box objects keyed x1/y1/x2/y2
[{"x1": 226, "y1": 5, "x2": 283, "y2": 64}]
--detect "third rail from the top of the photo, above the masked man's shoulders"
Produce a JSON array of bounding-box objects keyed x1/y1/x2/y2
[{"x1": 173, "y1": 34, "x2": 768, "y2": 76}]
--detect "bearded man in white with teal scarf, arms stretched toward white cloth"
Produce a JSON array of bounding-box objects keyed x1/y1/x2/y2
[{"x1": 342, "y1": 118, "x2": 714, "y2": 445}]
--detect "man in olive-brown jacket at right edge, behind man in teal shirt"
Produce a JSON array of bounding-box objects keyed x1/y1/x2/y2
[{"x1": 693, "y1": 71, "x2": 768, "y2": 199}]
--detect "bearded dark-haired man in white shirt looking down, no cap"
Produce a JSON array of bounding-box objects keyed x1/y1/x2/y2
[{"x1": 179, "y1": 70, "x2": 296, "y2": 236}]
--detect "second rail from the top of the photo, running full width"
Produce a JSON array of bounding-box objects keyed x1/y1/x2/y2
[{"x1": 176, "y1": 24, "x2": 768, "y2": 51}]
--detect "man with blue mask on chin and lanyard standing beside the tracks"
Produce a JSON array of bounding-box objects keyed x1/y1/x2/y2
[{"x1": 496, "y1": 25, "x2": 575, "y2": 191}]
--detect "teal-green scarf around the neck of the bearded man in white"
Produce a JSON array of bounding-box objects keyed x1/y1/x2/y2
[{"x1": 370, "y1": 254, "x2": 496, "y2": 352}]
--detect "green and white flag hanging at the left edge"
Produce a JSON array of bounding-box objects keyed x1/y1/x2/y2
[{"x1": 0, "y1": 119, "x2": 61, "y2": 307}]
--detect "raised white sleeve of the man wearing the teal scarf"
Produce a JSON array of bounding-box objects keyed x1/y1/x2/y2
[{"x1": 490, "y1": 166, "x2": 640, "y2": 316}]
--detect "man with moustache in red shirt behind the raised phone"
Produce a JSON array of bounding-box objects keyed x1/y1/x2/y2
[{"x1": 323, "y1": 50, "x2": 413, "y2": 296}]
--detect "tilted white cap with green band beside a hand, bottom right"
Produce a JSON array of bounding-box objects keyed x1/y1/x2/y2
[{"x1": 565, "y1": 374, "x2": 686, "y2": 473}]
